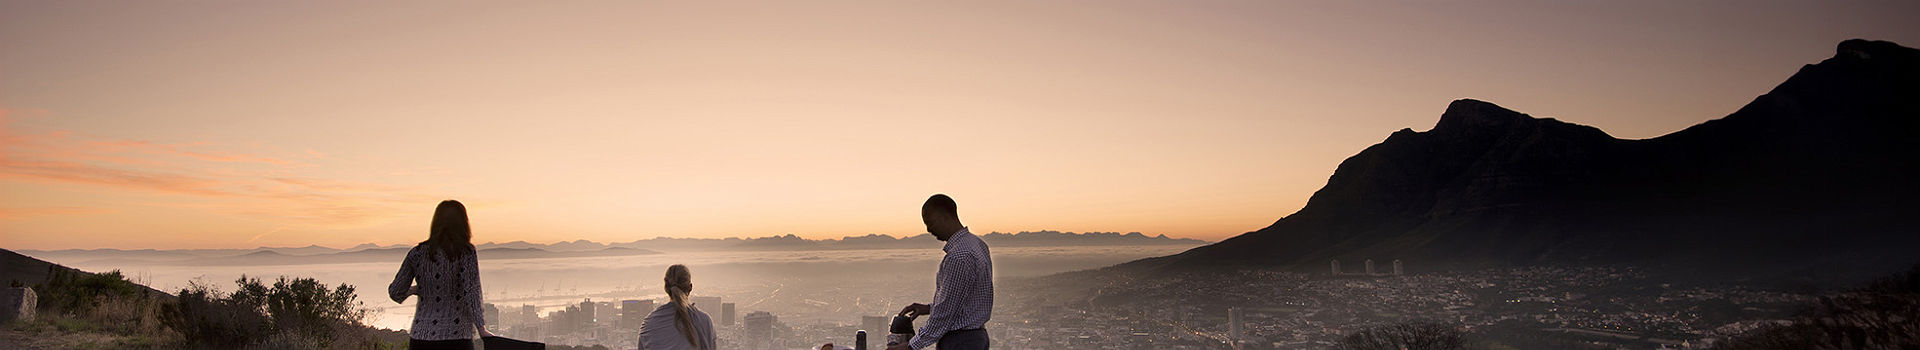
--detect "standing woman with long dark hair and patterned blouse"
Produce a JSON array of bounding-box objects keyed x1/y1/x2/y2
[{"x1": 386, "y1": 200, "x2": 493, "y2": 350}]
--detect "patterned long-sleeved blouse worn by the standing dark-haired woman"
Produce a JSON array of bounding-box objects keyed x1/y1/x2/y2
[{"x1": 386, "y1": 244, "x2": 486, "y2": 340}]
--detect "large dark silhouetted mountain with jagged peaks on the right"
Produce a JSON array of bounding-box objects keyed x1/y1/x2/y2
[{"x1": 1116, "y1": 40, "x2": 1920, "y2": 279}]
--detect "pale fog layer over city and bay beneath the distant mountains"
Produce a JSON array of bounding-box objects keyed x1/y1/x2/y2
[{"x1": 56, "y1": 238, "x2": 1192, "y2": 346}]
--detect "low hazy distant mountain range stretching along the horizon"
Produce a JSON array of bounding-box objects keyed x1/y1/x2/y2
[{"x1": 19, "y1": 231, "x2": 1206, "y2": 265}]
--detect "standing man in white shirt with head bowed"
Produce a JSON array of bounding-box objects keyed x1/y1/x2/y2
[{"x1": 887, "y1": 194, "x2": 993, "y2": 350}]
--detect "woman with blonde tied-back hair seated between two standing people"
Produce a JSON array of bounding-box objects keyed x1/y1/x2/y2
[{"x1": 639, "y1": 265, "x2": 720, "y2": 350}]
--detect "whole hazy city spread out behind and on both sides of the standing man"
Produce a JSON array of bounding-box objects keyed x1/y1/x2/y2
[{"x1": 464, "y1": 260, "x2": 1814, "y2": 350}]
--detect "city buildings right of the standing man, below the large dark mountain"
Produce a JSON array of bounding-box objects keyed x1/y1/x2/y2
[{"x1": 989, "y1": 263, "x2": 1816, "y2": 350}]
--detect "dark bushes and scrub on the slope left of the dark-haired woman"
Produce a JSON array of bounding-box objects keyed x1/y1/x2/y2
[{"x1": 18, "y1": 269, "x2": 407, "y2": 350}]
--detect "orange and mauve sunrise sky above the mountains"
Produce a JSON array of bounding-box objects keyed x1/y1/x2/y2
[{"x1": 0, "y1": 0, "x2": 1920, "y2": 250}]
